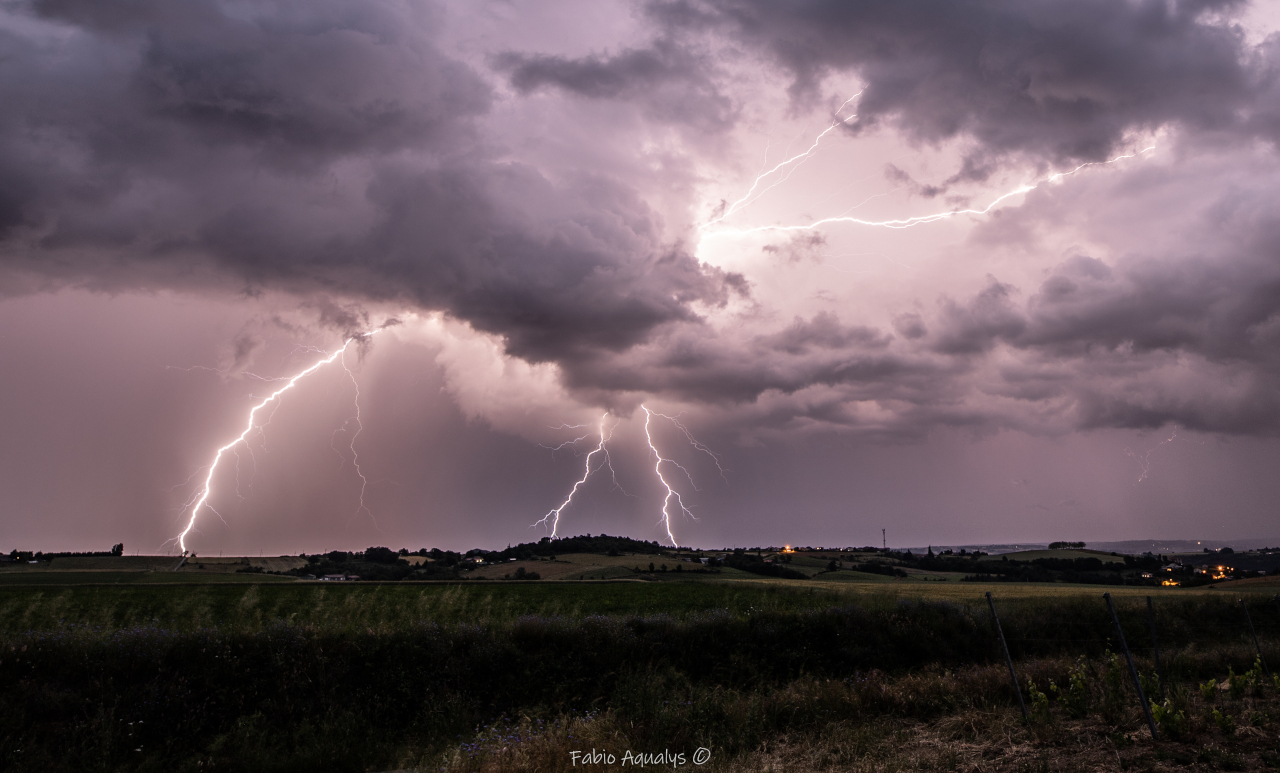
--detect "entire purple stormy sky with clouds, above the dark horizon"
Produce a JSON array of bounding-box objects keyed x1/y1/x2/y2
[{"x1": 0, "y1": 0, "x2": 1280, "y2": 555}]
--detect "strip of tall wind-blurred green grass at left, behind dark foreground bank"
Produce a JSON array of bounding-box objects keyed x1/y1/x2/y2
[{"x1": 0, "y1": 582, "x2": 842, "y2": 635}]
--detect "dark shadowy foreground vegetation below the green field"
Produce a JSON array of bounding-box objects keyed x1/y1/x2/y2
[{"x1": 0, "y1": 584, "x2": 1280, "y2": 772}]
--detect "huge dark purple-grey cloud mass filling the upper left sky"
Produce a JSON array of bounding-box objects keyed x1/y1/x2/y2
[{"x1": 0, "y1": 0, "x2": 745, "y2": 360}]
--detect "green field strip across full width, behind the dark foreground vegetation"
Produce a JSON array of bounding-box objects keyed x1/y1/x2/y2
[{"x1": 0, "y1": 557, "x2": 1280, "y2": 634}]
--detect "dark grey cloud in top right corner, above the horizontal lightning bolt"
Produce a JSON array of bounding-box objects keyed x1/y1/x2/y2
[{"x1": 649, "y1": 0, "x2": 1259, "y2": 163}]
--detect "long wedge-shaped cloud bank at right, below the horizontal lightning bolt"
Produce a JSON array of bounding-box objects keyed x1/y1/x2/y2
[{"x1": 560, "y1": 211, "x2": 1280, "y2": 436}]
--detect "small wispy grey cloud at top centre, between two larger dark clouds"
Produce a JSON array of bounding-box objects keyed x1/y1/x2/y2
[{"x1": 494, "y1": 38, "x2": 736, "y2": 131}]
